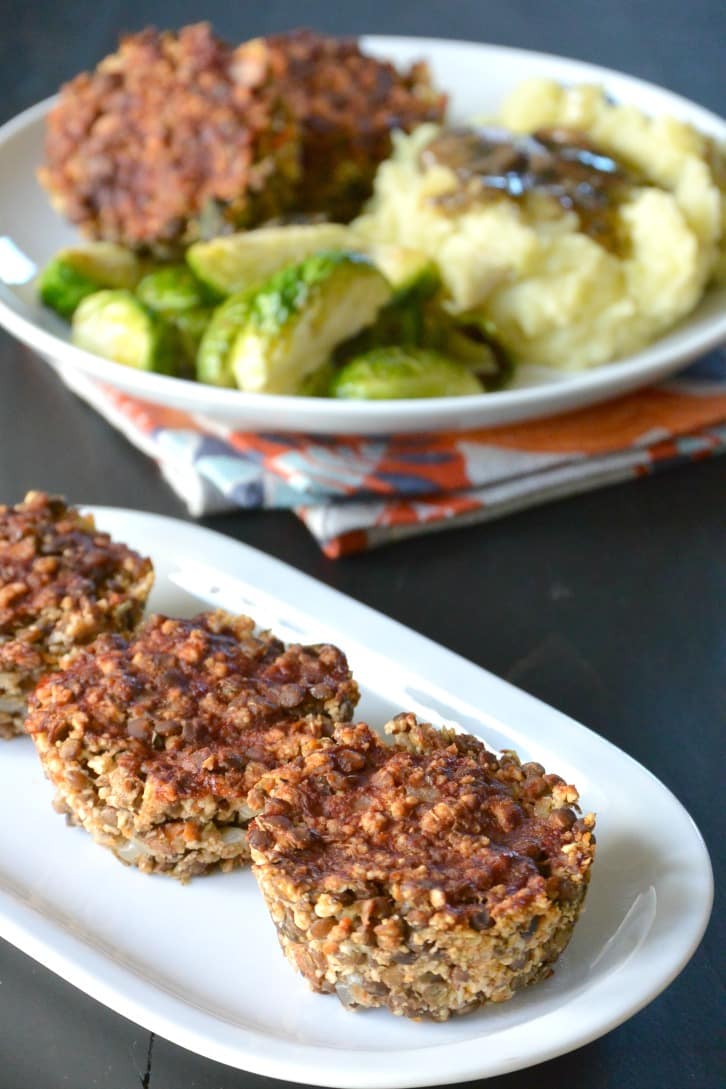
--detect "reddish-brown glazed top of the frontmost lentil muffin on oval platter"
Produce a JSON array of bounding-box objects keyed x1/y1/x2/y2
[{"x1": 249, "y1": 714, "x2": 593, "y2": 929}]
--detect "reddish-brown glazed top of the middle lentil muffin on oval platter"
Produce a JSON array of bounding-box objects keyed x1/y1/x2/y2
[{"x1": 26, "y1": 612, "x2": 358, "y2": 799}]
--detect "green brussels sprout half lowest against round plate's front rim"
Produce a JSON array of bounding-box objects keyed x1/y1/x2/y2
[{"x1": 330, "y1": 346, "x2": 484, "y2": 401}]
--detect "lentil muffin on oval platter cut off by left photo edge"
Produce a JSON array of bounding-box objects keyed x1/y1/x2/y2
[{"x1": 0, "y1": 491, "x2": 153, "y2": 737}]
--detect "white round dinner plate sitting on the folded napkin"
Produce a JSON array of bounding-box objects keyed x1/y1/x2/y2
[{"x1": 0, "y1": 37, "x2": 726, "y2": 435}]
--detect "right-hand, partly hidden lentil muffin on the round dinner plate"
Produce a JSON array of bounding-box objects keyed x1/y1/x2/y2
[{"x1": 236, "y1": 29, "x2": 446, "y2": 221}]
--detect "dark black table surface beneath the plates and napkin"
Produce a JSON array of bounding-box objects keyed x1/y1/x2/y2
[{"x1": 0, "y1": 0, "x2": 726, "y2": 1089}]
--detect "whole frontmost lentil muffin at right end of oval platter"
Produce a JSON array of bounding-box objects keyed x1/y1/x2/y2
[{"x1": 249, "y1": 714, "x2": 594, "y2": 1020}]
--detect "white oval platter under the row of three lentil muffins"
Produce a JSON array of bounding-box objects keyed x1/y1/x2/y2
[{"x1": 0, "y1": 507, "x2": 712, "y2": 1089}]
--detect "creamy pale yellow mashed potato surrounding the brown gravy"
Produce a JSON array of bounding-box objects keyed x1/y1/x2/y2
[{"x1": 355, "y1": 79, "x2": 726, "y2": 370}]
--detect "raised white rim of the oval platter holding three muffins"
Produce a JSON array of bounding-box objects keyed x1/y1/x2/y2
[{"x1": 0, "y1": 504, "x2": 713, "y2": 1089}]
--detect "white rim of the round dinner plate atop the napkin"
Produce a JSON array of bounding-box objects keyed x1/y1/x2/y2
[{"x1": 0, "y1": 35, "x2": 726, "y2": 433}]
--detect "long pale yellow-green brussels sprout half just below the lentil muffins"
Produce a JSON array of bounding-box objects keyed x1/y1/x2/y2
[{"x1": 186, "y1": 223, "x2": 355, "y2": 296}]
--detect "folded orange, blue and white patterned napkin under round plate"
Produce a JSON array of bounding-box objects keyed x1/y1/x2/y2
[{"x1": 63, "y1": 350, "x2": 726, "y2": 558}]
